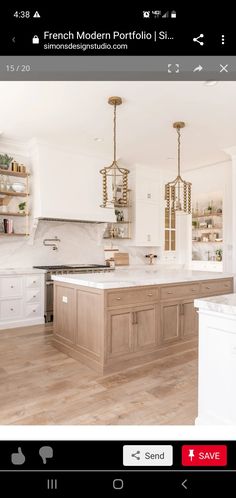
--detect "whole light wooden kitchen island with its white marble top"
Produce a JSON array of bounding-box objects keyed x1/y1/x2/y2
[{"x1": 50, "y1": 268, "x2": 233, "y2": 374}]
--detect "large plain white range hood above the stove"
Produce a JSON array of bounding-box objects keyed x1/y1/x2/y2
[{"x1": 32, "y1": 144, "x2": 115, "y2": 222}]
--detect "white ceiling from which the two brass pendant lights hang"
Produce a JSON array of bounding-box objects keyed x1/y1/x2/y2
[{"x1": 0, "y1": 82, "x2": 236, "y2": 170}]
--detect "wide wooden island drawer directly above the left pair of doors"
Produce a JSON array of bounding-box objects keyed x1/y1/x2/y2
[{"x1": 107, "y1": 288, "x2": 158, "y2": 307}]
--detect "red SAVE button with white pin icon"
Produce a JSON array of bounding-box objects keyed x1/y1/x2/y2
[{"x1": 182, "y1": 444, "x2": 227, "y2": 467}]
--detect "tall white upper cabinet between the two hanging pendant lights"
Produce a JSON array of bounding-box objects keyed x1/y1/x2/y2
[{"x1": 130, "y1": 166, "x2": 161, "y2": 247}]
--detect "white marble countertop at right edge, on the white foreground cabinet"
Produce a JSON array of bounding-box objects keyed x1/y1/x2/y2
[{"x1": 194, "y1": 294, "x2": 236, "y2": 315}]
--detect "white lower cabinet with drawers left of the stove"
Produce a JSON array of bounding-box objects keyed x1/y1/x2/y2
[{"x1": 0, "y1": 274, "x2": 44, "y2": 330}]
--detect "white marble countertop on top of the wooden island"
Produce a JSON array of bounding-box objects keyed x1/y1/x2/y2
[{"x1": 52, "y1": 267, "x2": 233, "y2": 289}]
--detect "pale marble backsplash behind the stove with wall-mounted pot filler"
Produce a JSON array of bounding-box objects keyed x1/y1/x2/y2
[{"x1": 0, "y1": 221, "x2": 164, "y2": 268}]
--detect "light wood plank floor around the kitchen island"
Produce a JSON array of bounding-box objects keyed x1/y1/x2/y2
[{"x1": 0, "y1": 325, "x2": 197, "y2": 425}]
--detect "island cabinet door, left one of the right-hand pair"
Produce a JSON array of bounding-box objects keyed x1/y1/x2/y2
[{"x1": 161, "y1": 302, "x2": 181, "y2": 344}]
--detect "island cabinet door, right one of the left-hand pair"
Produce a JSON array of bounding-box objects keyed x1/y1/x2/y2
[{"x1": 133, "y1": 305, "x2": 159, "y2": 351}]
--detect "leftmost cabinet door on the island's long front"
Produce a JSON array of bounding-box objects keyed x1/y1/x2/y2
[{"x1": 107, "y1": 310, "x2": 134, "y2": 359}]
